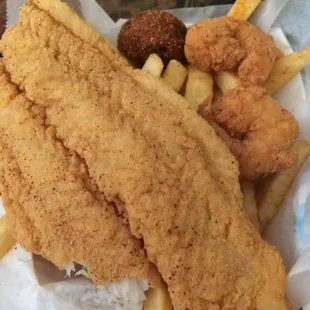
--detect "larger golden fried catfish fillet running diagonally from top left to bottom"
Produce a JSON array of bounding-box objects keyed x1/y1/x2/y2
[{"x1": 0, "y1": 0, "x2": 289, "y2": 310}]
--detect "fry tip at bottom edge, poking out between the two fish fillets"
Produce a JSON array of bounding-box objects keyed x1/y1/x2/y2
[{"x1": 143, "y1": 285, "x2": 173, "y2": 310}]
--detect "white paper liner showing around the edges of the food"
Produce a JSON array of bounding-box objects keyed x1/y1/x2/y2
[{"x1": 0, "y1": 0, "x2": 310, "y2": 310}]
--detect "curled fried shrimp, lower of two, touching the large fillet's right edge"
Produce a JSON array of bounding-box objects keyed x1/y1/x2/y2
[{"x1": 212, "y1": 87, "x2": 299, "y2": 179}]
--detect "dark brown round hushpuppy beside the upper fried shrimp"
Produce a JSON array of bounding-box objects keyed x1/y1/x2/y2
[{"x1": 117, "y1": 11, "x2": 187, "y2": 67}]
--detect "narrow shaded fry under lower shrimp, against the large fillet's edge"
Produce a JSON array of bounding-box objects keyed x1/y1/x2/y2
[{"x1": 241, "y1": 181, "x2": 259, "y2": 230}]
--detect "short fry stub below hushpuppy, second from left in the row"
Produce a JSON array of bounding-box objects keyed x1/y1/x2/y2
[{"x1": 162, "y1": 59, "x2": 187, "y2": 93}]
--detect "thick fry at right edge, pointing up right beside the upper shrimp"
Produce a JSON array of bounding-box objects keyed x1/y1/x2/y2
[{"x1": 266, "y1": 47, "x2": 310, "y2": 95}]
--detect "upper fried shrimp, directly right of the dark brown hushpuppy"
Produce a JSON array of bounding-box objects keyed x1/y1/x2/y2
[{"x1": 185, "y1": 16, "x2": 282, "y2": 86}]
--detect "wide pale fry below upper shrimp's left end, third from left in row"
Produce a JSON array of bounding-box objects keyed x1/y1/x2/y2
[{"x1": 184, "y1": 66, "x2": 213, "y2": 110}]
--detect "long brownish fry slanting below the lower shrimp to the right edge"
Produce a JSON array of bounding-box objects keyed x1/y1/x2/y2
[{"x1": 256, "y1": 140, "x2": 310, "y2": 230}]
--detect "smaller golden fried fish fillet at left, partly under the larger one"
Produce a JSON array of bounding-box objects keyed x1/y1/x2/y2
[{"x1": 0, "y1": 81, "x2": 155, "y2": 283}]
